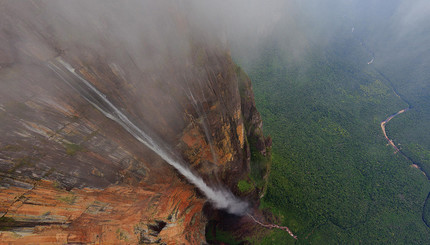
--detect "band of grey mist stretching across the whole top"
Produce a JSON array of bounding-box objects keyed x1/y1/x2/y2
[{"x1": 0, "y1": 0, "x2": 430, "y2": 113}]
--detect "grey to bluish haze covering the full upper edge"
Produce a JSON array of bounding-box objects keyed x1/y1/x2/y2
[{"x1": 2, "y1": 0, "x2": 430, "y2": 70}]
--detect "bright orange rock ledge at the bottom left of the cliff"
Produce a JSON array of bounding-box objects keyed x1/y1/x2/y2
[{"x1": 0, "y1": 180, "x2": 204, "y2": 244}]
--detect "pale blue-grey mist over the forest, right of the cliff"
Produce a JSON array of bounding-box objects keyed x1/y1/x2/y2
[{"x1": 217, "y1": 0, "x2": 430, "y2": 78}]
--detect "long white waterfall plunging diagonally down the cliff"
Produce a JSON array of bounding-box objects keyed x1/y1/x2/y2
[{"x1": 48, "y1": 57, "x2": 248, "y2": 215}]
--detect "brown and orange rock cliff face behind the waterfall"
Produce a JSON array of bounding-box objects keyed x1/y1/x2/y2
[{"x1": 0, "y1": 1, "x2": 270, "y2": 244}]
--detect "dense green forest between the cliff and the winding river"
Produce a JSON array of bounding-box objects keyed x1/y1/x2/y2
[{"x1": 237, "y1": 28, "x2": 430, "y2": 244}]
